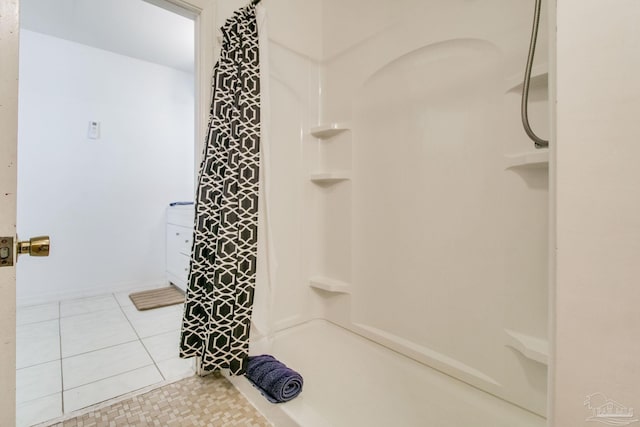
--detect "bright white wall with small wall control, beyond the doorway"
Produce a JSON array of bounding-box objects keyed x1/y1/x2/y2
[{"x1": 17, "y1": 30, "x2": 194, "y2": 304}]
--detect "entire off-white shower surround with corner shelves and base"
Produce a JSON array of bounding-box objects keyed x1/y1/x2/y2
[{"x1": 217, "y1": 0, "x2": 549, "y2": 427}]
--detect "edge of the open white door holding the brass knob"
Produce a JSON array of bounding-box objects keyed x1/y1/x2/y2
[{"x1": 0, "y1": 0, "x2": 19, "y2": 426}]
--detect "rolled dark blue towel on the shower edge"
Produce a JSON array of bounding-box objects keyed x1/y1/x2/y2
[{"x1": 245, "y1": 354, "x2": 302, "y2": 403}]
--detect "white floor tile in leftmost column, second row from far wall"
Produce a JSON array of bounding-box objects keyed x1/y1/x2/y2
[{"x1": 16, "y1": 319, "x2": 60, "y2": 369}]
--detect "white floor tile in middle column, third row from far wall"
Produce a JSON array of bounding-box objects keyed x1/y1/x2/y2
[{"x1": 62, "y1": 341, "x2": 153, "y2": 390}]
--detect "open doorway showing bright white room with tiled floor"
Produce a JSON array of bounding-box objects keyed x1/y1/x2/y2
[{"x1": 16, "y1": 0, "x2": 196, "y2": 425}]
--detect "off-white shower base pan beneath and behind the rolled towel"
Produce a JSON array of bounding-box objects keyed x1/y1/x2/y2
[{"x1": 229, "y1": 320, "x2": 546, "y2": 427}]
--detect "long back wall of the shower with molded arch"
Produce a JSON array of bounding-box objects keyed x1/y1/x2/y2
[{"x1": 318, "y1": 0, "x2": 548, "y2": 415}]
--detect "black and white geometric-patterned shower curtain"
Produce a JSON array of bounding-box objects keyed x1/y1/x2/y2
[{"x1": 180, "y1": 5, "x2": 260, "y2": 375}]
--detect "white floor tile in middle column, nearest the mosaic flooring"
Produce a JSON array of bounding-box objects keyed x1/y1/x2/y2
[{"x1": 63, "y1": 365, "x2": 162, "y2": 412}]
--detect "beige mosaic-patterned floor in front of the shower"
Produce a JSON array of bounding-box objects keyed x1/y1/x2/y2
[{"x1": 51, "y1": 373, "x2": 271, "y2": 427}]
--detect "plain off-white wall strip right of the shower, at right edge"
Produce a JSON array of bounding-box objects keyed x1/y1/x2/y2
[{"x1": 552, "y1": 0, "x2": 640, "y2": 427}]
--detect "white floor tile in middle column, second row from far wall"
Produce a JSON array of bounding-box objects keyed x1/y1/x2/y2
[{"x1": 60, "y1": 308, "x2": 138, "y2": 358}]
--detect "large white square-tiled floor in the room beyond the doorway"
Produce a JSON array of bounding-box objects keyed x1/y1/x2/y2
[{"x1": 16, "y1": 292, "x2": 193, "y2": 427}]
